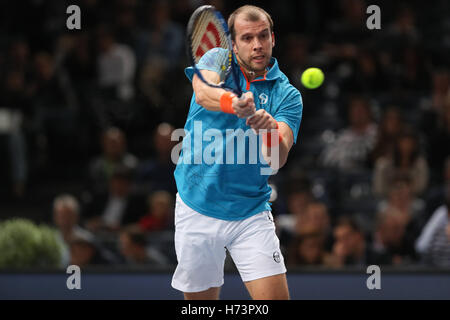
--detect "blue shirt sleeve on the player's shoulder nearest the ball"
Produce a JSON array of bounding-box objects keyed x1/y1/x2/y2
[{"x1": 273, "y1": 86, "x2": 303, "y2": 144}]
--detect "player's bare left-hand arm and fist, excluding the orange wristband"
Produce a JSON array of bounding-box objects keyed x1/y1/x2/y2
[{"x1": 192, "y1": 70, "x2": 256, "y2": 118}]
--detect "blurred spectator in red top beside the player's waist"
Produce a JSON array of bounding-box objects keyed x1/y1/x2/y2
[{"x1": 139, "y1": 191, "x2": 174, "y2": 232}]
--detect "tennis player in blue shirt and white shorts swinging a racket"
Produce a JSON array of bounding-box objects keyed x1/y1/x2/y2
[{"x1": 172, "y1": 5, "x2": 303, "y2": 300}]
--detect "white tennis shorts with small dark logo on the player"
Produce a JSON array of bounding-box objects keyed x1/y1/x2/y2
[{"x1": 172, "y1": 194, "x2": 286, "y2": 292}]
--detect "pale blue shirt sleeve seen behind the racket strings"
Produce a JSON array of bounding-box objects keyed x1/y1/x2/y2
[{"x1": 184, "y1": 48, "x2": 228, "y2": 81}]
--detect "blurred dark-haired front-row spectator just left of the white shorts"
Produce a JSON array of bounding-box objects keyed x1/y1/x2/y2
[{"x1": 119, "y1": 227, "x2": 168, "y2": 266}]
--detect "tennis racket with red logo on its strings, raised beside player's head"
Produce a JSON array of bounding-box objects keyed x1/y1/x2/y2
[{"x1": 187, "y1": 5, "x2": 242, "y2": 98}]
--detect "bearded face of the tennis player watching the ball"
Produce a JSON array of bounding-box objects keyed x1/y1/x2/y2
[{"x1": 233, "y1": 15, "x2": 275, "y2": 72}]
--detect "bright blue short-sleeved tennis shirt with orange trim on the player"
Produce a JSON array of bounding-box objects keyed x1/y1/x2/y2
[{"x1": 174, "y1": 48, "x2": 303, "y2": 220}]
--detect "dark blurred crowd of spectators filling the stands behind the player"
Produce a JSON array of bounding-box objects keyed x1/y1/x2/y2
[{"x1": 0, "y1": 0, "x2": 450, "y2": 268}]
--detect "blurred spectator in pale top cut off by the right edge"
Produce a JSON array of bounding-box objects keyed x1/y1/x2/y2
[{"x1": 415, "y1": 184, "x2": 450, "y2": 268}]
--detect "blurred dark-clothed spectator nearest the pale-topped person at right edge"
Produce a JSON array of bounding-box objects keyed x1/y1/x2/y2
[{"x1": 372, "y1": 208, "x2": 416, "y2": 265}]
